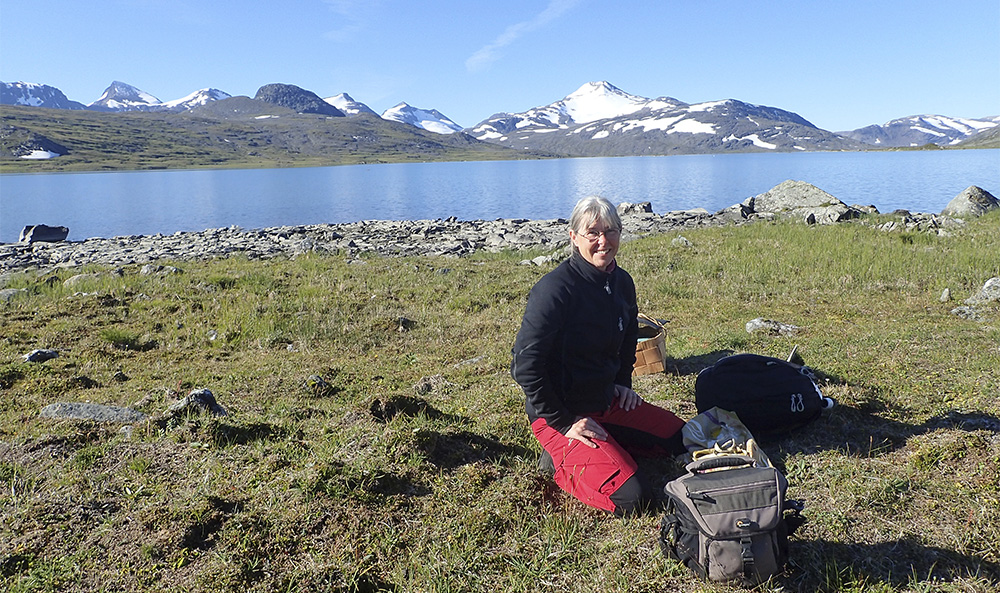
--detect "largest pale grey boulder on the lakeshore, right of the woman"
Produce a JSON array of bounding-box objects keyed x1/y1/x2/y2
[{"x1": 744, "y1": 180, "x2": 860, "y2": 224}]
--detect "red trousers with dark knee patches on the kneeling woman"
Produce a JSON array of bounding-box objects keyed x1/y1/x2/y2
[{"x1": 531, "y1": 398, "x2": 684, "y2": 513}]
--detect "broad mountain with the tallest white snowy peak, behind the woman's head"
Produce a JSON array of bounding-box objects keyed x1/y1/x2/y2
[{"x1": 470, "y1": 81, "x2": 859, "y2": 156}]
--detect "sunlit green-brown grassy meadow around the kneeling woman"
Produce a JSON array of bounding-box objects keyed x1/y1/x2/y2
[{"x1": 0, "y1": 212, "x2": 1000, "y2": 593}]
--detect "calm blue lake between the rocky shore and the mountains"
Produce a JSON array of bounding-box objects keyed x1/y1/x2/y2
[{"x1": 0, "y1": 150, "x2": 1000, "y2": 243}]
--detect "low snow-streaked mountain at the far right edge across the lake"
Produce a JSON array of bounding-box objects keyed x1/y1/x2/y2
[{"x1": 840, "y1": 115, "x2": 1000, "y2": 147}]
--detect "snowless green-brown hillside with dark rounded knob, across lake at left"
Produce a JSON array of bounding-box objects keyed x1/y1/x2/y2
[{"x1": 0, "y1": 103, "x2": 551, "y2": 172}]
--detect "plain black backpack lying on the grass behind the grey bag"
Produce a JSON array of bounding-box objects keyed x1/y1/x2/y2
[{"x1": 694, "y1": 354, "x2": 835, "y2": 437}]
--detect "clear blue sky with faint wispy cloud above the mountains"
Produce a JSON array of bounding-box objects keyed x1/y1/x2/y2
[{"x1": 0, "y1": 0, "x2": 1000, "y2": 131}]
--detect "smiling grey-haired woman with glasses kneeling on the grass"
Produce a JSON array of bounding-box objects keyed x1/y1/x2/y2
[{"x1": 511, "y1": 197, "x2": 685, "y2": 516}]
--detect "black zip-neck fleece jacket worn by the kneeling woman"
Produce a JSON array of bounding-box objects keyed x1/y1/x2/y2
[{"x1": 511, "y1": 253, "x2": 638, "y2": 434}]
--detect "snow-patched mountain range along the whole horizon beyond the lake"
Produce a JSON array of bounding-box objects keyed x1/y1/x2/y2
[{"x1": 0, "y1": 81, "x2": 1000, "y2": 156}]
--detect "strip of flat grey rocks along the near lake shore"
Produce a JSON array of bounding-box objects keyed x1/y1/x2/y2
[{"x1": 0, "y1": 203, "x2": 960, "y2": 274}]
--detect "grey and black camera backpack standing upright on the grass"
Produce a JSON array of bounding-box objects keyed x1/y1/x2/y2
[{"x1": 659, "y1": 455, "x2": 802, "y2": 586}]
